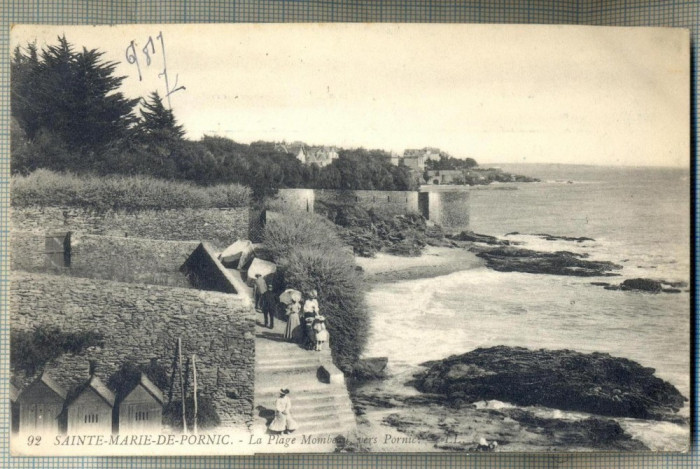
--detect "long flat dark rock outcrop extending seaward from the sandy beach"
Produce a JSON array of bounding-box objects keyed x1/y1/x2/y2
[{"x1": 470, "y1": 246, "x2": 622, "y2": 277}]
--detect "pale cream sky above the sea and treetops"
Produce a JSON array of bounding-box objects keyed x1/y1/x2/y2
[{"x1": 11, "y1": 23, "x2": 690, "y2": 167}]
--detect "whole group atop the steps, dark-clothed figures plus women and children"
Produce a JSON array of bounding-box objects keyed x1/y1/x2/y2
[{"x1": 254, "y1": 274, "x2": 329, "y2": 352}]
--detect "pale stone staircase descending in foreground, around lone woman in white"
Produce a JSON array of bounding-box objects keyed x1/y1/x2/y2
[{"x1": 252, "y1": 316, "x2": 355, "y2": 452}]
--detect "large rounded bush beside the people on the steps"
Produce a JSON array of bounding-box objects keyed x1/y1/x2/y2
[{"x1": 265, "y1": 214, "x2": 369, "y2": 373}]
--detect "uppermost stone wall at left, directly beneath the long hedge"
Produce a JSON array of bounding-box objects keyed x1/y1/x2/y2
[{"x1": 10, "y1": 206, "x2": 249, "y2": 247}]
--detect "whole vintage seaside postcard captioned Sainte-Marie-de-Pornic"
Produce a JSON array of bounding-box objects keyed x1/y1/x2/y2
[{"x1": 7, "y1": 24, "x2": 692, "y2": 455}]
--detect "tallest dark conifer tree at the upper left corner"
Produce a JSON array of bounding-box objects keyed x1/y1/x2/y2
[{"x1": 11, "y1": 36, "x2": 139, "y2": 160}]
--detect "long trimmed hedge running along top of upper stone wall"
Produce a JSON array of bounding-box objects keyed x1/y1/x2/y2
[{"x1": 10, "y1": 169, "x2": 250, "y2": 211}]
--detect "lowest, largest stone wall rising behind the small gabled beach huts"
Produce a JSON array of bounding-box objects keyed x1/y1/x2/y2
[{"x1": 9, "y1": 272, "x2": 255, "y2": 428}]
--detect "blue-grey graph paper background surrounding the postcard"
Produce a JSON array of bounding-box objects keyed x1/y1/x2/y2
[{"x1": 0, "y1": 0, "x2": 700, "y2": 469}]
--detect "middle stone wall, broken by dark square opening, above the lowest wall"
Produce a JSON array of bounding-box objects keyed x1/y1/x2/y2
[{"x1": 10, "y1": 231, "x2": 198, "y2": 288}]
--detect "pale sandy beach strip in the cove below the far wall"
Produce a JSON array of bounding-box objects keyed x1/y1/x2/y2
[{"x1": 355, "y1": 246, "x2": 484, "y2": 283}]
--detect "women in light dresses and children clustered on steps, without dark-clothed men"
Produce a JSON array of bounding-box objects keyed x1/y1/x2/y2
[{"x1": 284, "y1": 290, "x2": 328, "y2": 352}]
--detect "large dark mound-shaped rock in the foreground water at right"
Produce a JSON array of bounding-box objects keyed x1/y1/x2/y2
[{"x1": 414, "y1": 346, "x2": 687, "y2": 421}]
